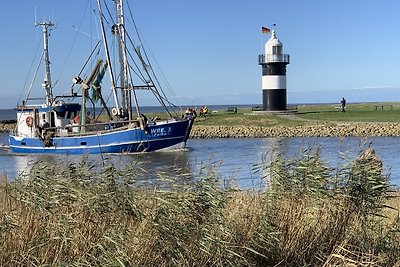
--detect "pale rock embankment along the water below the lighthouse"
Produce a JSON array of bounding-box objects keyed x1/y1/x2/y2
[{"x1": 190, "y1": 123, "x2": 400, "y2": 138}]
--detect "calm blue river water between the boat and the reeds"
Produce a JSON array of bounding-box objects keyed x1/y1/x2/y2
[{"x1": 0, "y1": 137, "x2": 400, "y2": 190}]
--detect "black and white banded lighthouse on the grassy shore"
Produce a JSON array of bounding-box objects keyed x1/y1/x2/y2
[{"x1": 258, "y1": 30, "x2": 290, "y2": 111}]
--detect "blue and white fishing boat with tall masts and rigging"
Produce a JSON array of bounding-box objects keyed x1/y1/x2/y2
[{"x1": 9, "y1": 0, "x2": 194, "y2": 154}]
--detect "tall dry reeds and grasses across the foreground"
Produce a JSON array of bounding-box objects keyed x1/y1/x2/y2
[{"x1": 0, "y1": 150, "x2": 400, "y2": 266}]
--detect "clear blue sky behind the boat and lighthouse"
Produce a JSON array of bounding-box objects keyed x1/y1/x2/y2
[{"x1": 0, "y1": 0, "x2": 400, "y2": 108}]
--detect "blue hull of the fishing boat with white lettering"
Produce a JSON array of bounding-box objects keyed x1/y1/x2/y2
[{"x1": 9, "y1": 120, "x2": 192, "y2": 154}]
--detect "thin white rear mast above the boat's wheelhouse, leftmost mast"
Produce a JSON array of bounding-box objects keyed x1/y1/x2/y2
[{"x1": 35, "y1": 21, "x2": 55, "y2": 106}]
